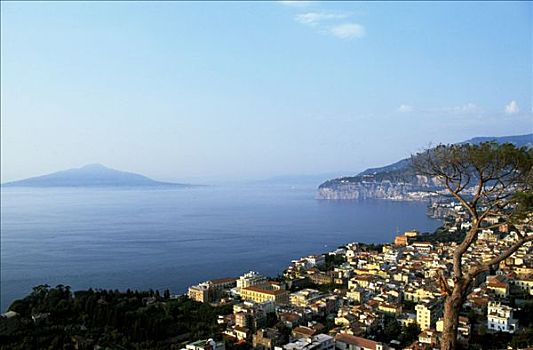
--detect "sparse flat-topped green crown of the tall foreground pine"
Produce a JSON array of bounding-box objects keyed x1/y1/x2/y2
[{"x1": 411, "y1": 142, "x2": 533, "y2": 219}]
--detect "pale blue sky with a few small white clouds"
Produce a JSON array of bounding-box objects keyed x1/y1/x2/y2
[{"x1": 0, "y1": 1, "x2": 533, "y2": 182}]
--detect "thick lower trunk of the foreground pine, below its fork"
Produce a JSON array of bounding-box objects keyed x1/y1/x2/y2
[{"x1": 441, "y1": 284, "x2": 464, "y2": 350}]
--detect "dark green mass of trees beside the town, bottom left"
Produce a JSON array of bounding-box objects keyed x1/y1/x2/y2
[{"x1": 0, "y1": 285, "x2": 231, "y2": 349}]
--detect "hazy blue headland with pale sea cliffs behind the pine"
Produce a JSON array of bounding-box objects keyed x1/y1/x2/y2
[{"x1": 318, "y1": 134, "x2": 533, "y2": 200}]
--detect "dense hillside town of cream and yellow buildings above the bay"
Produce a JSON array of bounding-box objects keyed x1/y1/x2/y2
[{"x1": 186, "y1": 203, "x2": 533, "y2": 350}]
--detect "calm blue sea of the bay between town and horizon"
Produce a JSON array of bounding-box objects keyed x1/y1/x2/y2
[{"x1": 1, "y1": 185, "x2": 439, "y2": 310}]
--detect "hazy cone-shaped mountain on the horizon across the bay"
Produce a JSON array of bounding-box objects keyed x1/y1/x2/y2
[{"x1": 2, "y1": 164, "x2": 188, "y2": 187}]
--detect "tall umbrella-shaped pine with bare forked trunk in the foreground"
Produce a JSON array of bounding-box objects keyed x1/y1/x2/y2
[{"x1": 411, "y1": 142, "x2": 533, "y2": 350}]
